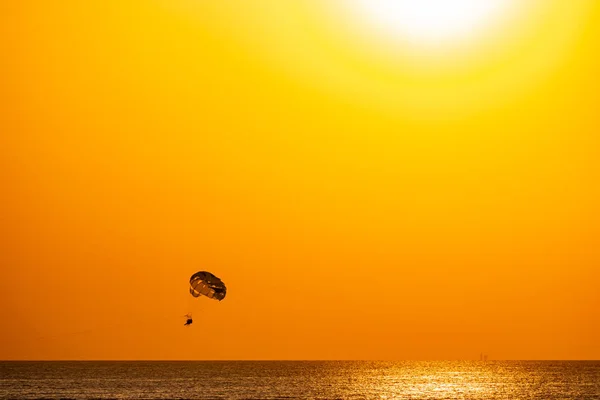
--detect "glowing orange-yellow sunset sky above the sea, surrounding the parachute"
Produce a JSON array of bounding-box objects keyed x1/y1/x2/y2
[{"x1": 0, "y1": 0, "x2": 600, "y2": 359}]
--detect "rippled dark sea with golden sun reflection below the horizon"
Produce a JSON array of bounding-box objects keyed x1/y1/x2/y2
[{"x1": 0, "y1": 361, "x2": 600, "y2": 400}]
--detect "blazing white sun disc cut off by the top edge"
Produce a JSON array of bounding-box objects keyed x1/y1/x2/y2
[{"x1": 353, "y1": 0, "x2": 513, "y2": 45}]
